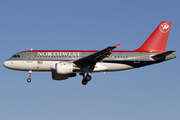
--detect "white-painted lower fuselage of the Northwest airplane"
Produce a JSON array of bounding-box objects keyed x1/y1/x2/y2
[{"x1": 6, "y1": 61, "x2": 133, "y2": 72}]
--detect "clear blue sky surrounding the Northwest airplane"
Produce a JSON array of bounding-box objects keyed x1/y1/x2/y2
[{"x1": 0, "y1": 0, "x2": 180, "y2": 120}]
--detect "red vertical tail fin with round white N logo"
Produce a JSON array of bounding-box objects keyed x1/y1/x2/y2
[{"x1": 135, "y1": 21, "x2": 171, "y2": 52}]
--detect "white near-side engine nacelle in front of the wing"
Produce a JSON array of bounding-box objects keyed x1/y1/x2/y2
[{"x1": 55, "y1": 62, "x2": 73, "y2": 74}]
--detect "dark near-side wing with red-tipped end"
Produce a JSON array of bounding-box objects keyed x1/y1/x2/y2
[{"x1": 73, "y1": 44, "x2": 120, "y2": 69}]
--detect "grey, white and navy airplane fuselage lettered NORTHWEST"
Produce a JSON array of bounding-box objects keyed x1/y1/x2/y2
[{"x1": 4, "y1": 50, "x2": 175, "y2": 73}]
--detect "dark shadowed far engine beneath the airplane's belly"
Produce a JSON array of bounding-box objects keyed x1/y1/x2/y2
[{"x1": 52, "y1": 71, "x2": 76, "y2": 80}]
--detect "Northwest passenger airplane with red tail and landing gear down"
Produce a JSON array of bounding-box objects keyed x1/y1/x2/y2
[{"x1": 3, "y1": 21, "x2": 176, "y2": 85}]
